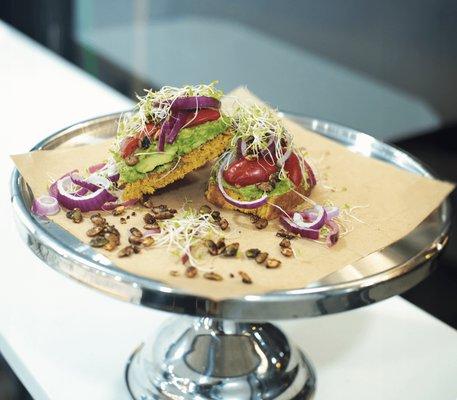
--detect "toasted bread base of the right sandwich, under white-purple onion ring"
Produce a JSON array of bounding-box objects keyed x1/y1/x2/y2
[{"x1": 205, "y1": 181, "x2": 311, "y2": 219}]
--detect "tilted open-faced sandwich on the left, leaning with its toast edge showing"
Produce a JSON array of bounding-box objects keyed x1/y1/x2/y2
[{"x1": 112, "y1": 82, "x2": 231, "y2": 200}]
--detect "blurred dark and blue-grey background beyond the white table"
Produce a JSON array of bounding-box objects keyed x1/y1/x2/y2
[{"x1": 0, "y1": 0, "x2": 457, "y2": 400}]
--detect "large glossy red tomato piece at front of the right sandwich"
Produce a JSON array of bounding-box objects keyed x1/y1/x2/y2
[{"x1": 223, "y1": 157, "x2": 277, "y2": 187}]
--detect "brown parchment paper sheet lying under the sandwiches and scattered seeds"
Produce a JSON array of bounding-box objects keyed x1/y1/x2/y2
[{"x1": 12, "y1": 88, "x2": 453, "y2": 299}]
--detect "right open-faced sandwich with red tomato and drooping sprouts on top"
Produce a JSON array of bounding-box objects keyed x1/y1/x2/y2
[{"x1": 206, "y1": 104, "x2": 316, "y2": 219}]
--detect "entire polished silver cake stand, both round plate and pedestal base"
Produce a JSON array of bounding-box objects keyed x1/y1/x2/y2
[{"x1": 11, "y1": 114, "x2": 450, "y2": 400}]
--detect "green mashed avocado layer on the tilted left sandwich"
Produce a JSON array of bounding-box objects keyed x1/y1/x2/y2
[{"x1": 116, "y1": 118, "x2": 228, "y2": 183}]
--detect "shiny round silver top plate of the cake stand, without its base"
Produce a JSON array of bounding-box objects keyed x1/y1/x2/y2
[{"x1": 11, "y1": 114, "x2": 450, "y2": 322}]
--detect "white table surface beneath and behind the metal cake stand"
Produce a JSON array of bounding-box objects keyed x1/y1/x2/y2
[{"x1": 0, "y1": 22, "x2": 457, "y2": 400}]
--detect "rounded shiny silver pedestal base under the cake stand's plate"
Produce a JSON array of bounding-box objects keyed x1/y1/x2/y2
[{"x1": 125, "y1": 317, "x2": 316, "y2": 400}]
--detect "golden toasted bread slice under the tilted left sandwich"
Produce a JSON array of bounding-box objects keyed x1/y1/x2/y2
[{"x1": 122, "y1": 130, "x2": 232, "y2": 200}]
